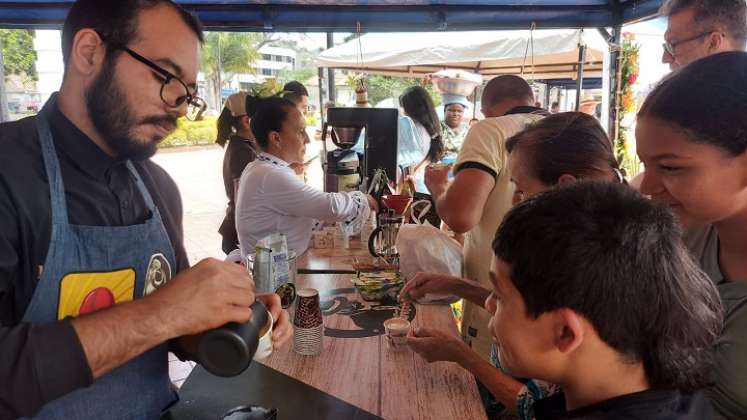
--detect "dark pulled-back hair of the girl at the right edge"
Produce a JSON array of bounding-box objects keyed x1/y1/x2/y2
[{"x1": 638, "y1": 51, "x2": 747, "y2": 156}]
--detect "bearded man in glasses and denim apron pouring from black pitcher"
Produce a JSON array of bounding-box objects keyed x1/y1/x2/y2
[{"x1": 0, "y1": 0, "x2": 291, "y2": 419}]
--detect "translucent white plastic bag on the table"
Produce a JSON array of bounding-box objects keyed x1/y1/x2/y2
[{"x1": 397, "y1": 218, "x2": 464, "y2": 303}]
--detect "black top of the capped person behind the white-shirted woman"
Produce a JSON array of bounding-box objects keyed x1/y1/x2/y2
[{"x1": 218, "y1": 136, "x2": 257, "y2": 253}]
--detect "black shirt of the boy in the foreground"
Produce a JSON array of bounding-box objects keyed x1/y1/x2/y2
[{"x1": 534, "y1": 389, "x2": 715, "y2": 420}]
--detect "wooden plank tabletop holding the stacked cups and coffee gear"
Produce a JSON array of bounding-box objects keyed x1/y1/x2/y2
[{"x1": 261, "y1": 249, "x2": 486, "y2": 420}]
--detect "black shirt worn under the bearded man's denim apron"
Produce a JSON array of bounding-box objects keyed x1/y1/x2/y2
[{"x1": 0, "y1": 108, "x2": 189, "y2": 419}]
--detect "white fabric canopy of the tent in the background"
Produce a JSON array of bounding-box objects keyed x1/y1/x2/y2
[{"x1": 317, "y1": 29, "x2": 607, "y2": 79}]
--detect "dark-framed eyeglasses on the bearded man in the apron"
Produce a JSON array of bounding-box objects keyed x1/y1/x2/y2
[{"x1": 101, "y1": 36, "x2": 207, "y2": 121}]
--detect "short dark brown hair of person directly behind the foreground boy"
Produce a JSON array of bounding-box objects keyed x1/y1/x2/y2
[{"x1": 506, "y1": 112, "x2": 620, "y2": 185}]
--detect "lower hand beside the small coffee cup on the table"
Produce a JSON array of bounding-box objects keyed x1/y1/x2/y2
[{"x1": 407, "y1": 328, "x2": 470, "y2": 363}]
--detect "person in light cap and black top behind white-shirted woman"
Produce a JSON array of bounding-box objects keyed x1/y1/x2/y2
[{"x1": 215, "y1": 91, "x2": 258, "y2": 254}]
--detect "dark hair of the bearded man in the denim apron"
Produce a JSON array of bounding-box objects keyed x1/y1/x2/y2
[{"x1": 62, "y1": 0, "x2": 204, "y2": 65}]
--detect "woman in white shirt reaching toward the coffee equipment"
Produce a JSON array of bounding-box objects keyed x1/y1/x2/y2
[{"x1": 236, "y1": 97, "x2": 376, "y2": 257}]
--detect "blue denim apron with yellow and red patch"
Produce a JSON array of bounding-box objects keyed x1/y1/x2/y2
[{"x1": 23, "y1": 97, "x2": 178, "y2": 420}]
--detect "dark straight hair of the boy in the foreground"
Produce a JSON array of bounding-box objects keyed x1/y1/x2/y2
[{"x1": 493, "y1": 181, "x2": 723, "y2": 391}]
